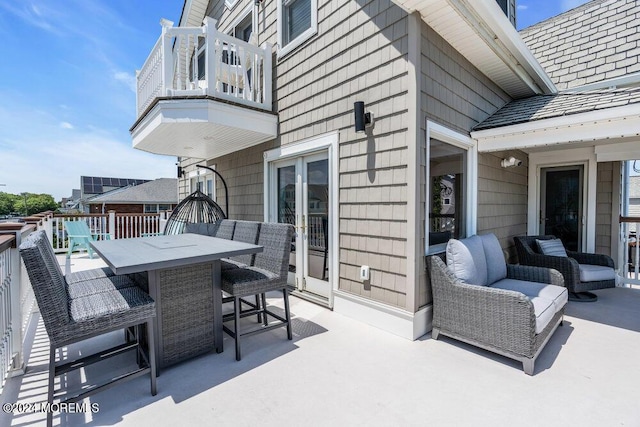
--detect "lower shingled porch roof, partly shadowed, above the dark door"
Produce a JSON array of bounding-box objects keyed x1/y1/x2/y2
[{"x1": 473, "y1": 88, "x2": 640, "y2": 130}]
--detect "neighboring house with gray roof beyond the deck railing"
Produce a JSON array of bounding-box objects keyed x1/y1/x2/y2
[{"x1": 86, "y1": 178, "x2": 178, "y2": 213}]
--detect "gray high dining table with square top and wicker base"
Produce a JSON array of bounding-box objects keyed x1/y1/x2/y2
[{"x1": 91, "y1": 233, "x2": 263, "y2": 367}]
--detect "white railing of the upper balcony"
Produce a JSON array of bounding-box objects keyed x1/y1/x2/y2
[{"x1": 136, "y1": 17, "x2": 272, "y2": 117}]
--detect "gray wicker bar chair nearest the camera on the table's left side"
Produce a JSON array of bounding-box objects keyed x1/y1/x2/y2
[{"x1": 20, "y1": 231, "x2": 156, "y2": 426}]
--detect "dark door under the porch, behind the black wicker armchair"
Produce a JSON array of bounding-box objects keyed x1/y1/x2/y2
[{"x1": 541, "y1": 166, "x2": 583, "y2": 251}]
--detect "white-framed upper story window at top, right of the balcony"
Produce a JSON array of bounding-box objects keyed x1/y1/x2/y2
[{"x1": 278, "y1": 0, "x2": 318, "y2": 55}]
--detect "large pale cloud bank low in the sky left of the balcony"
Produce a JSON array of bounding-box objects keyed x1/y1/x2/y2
[{"x1": 0, "y1": 99, "x2": 176, "y2": 200}]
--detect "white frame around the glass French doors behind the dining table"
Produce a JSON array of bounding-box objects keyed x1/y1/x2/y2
[{"x1": 264, "y1": 132, "x2": 340, "y2": 307}]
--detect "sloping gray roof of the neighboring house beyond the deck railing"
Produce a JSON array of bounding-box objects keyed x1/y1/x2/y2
[{"x1": 87, "y1": 178, "x2": 178, "y2": 204}]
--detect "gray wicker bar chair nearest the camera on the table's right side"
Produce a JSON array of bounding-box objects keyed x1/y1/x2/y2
[{"x1": 222, "y1": 223, "x2": 293, "y2": 360}]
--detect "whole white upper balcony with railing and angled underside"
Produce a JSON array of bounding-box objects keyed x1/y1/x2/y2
[{"x1": 130, "y1": 18, "x2": 278, "y2": 159}]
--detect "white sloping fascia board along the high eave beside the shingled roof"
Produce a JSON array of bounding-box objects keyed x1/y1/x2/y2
[{"x1": 450, "y1": 0, "x2": 558, "y2": 94}]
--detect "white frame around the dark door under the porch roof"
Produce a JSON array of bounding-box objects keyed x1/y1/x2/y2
[{"x1": 527, "y1": 148, "x2": 598, "y2": 252}]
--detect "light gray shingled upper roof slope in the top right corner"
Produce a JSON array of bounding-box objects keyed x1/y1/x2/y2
[{"x1": 520, "y1": 0, "x2": 640, "y2": 90}]
